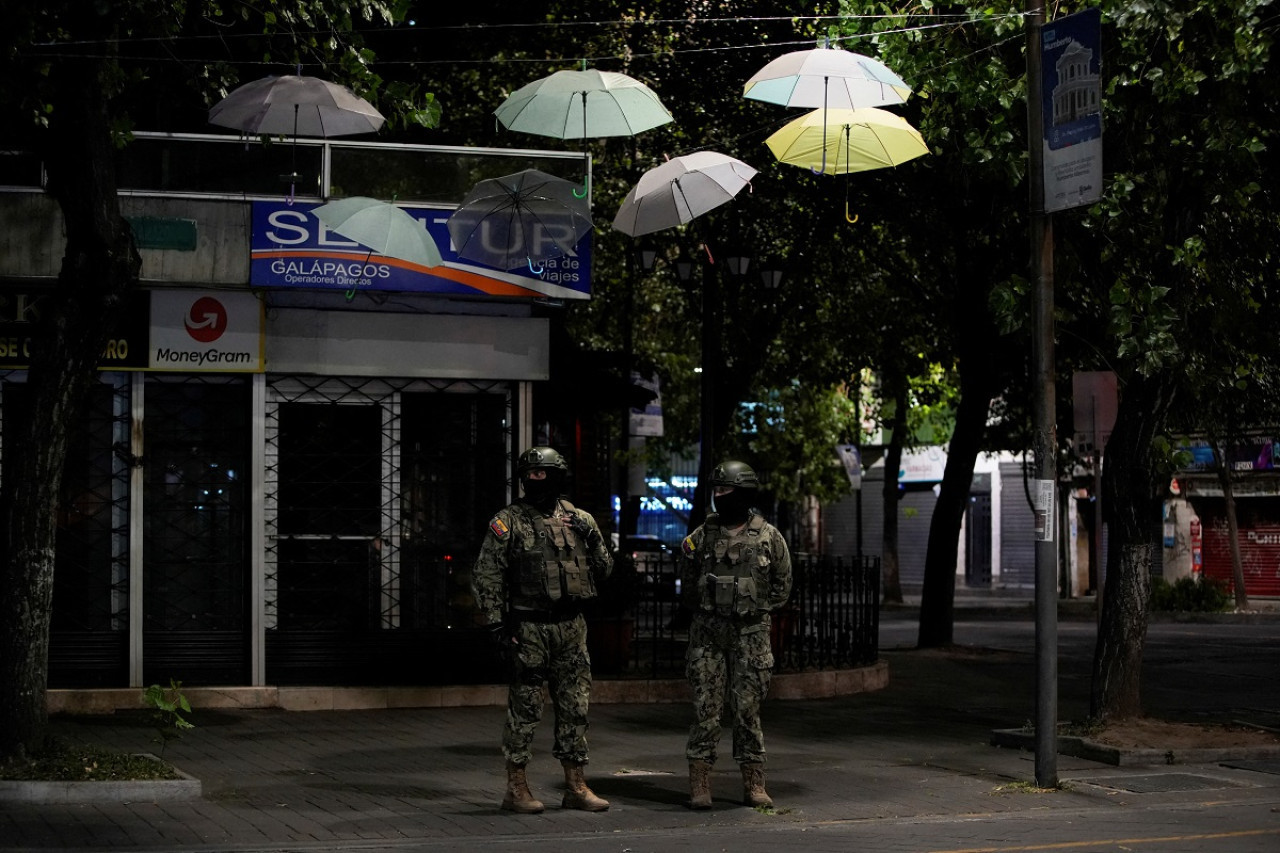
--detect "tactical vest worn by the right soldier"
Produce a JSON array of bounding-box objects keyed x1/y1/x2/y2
[{"x1": 699, "y1": 515, "x2": 772, "y2": 616}]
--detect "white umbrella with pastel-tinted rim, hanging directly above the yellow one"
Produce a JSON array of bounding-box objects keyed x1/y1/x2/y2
[{"x1": 742, "y1": 47, "x2": 911, "y2": 110}]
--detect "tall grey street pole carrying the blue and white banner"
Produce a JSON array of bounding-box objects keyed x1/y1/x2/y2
[{"x1": 1027, "y1": 0, "x2": 1057, "y2": 788}]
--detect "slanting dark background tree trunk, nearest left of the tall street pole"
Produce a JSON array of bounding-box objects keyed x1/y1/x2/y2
[{"x1": 918, "y1": 357, "x2": 992, "y2": 648}]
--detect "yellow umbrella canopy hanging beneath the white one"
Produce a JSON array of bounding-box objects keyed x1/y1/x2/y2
[{"x1": 764, "y1": 106, "x2": 929, "y2": 174}]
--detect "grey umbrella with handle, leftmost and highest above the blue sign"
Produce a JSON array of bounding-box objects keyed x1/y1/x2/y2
[{"x1": 209, "y1": 74, "x2": 385, "y2": 201}]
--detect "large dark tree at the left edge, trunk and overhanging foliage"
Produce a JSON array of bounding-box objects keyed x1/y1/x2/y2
[{"x1": 0, "y1": 0, "x2": 431, "y2": 760}]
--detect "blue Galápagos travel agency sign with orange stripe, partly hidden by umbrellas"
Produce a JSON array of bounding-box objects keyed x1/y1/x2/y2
[{"x1": 250, "y1": 201, "x2": 591, "y2": 300}]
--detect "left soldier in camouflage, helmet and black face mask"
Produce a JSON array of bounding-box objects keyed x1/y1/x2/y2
[{"x1": 471, "y1": 447, "x2": 613, "y2": 815}]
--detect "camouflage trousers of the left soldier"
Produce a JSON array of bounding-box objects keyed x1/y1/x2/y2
[{"x1": 502, "y1": 615, "x2": 591, "y2": 766}]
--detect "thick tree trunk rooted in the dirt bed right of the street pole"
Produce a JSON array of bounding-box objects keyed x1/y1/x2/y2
[{"x1": 1091, "y1": 375, "x2": 1172, "y2": 721}]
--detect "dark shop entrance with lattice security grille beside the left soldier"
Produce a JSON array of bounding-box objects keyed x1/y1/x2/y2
[{"x1": 262, "y1": 377, "x2": 513, "y2": 684}]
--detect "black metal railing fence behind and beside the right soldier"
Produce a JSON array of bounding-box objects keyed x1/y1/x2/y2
[{"x1": 588, "y1": 553, "x2": 879, "y2": 678}]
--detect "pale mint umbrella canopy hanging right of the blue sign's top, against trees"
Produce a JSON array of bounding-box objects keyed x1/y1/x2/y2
[{"x1": 494, "y1": 70, "x2": 672, "y2": 140}]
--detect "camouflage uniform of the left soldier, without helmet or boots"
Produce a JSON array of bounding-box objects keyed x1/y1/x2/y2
[{"x1": 471, "y1": 491, "x2": 613, "y2": 766}]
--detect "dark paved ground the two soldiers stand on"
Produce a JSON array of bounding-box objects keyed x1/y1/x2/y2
[{"x1": 0, "y1": 602, "x2": 1280, "y2": 853}]
